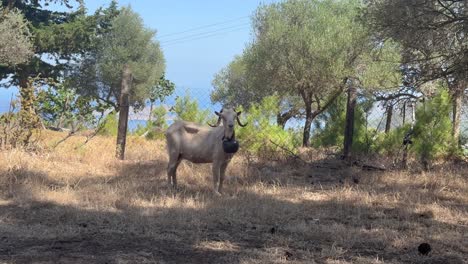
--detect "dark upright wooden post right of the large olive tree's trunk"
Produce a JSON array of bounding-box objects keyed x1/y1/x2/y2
[{"x1": 343, "y1": 85, "x2": 357, "y2": 160}]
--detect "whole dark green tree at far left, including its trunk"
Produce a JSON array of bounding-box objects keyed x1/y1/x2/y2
[{"x1": 0, "y1": 0, "x2": 113, "y2": 144}]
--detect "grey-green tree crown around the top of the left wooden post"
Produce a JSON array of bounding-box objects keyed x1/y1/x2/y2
[{"x1": 70, "y1": 7, "x2": 167, "y2": 111}]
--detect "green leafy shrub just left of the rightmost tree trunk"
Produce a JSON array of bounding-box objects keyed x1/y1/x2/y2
[{"x1": 414, "y1": 89, "x2": 455, "y2": 167}]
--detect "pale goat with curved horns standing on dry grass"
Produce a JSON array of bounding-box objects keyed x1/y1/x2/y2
[{"x1": 165, "y1": 107, "x2": 247, "y2": 195}]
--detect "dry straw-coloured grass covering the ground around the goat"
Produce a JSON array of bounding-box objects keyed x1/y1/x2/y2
[{"x1": 0, "y1": 132, "x2": 468, "y2": 264}]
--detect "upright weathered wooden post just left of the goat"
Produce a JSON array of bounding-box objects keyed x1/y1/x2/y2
[{"x1": 115, "y1": 64, "x2": 132, "y2": 160}]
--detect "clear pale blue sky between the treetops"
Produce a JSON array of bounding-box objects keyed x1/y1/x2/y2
[{"x1": 0, "y1": 0, "x2": 275, "y2": 112}]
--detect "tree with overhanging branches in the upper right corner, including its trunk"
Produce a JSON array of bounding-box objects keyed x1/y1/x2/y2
[{"x1": 366, "y1": 0, "x2": 468, "y2": 145}]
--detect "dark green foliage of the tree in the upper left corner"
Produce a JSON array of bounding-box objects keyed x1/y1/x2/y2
[{"x1": 0, "y1": 0, "x2": 103, "y2": 87}]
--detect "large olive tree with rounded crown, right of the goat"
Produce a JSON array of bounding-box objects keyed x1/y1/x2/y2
[{"x1": 246, "y1": 0, "x2": 369, "y2": 146}]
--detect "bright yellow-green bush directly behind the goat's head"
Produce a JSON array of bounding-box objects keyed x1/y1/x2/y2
[{"x1": 236, "y1": 96, "x2": 299, "y2": 155}]
